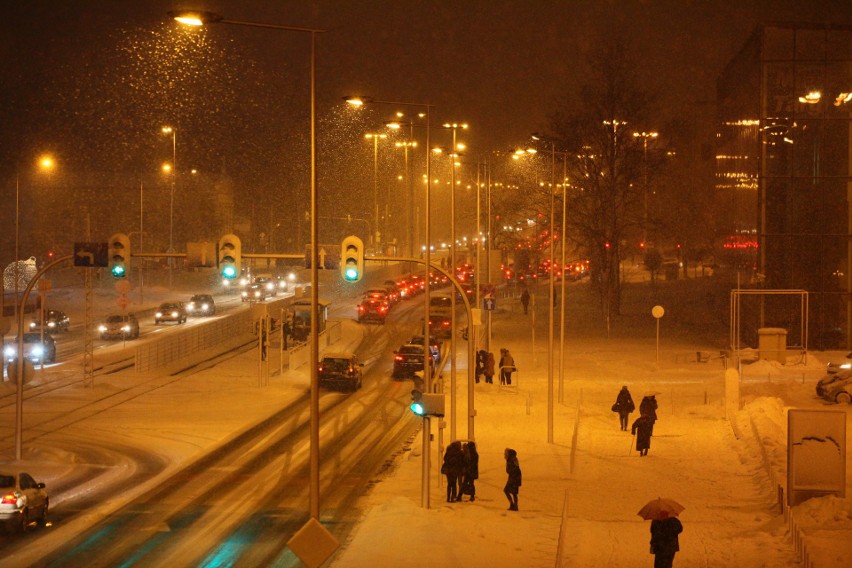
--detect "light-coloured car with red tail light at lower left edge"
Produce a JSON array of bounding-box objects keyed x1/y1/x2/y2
[{"x1": 0, "y1": 470, "x2": 50, "y2": 532}]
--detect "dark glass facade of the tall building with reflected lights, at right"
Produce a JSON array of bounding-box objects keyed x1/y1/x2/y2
[{"x1": 716, "y1": 24, "x2": 852, "y2": 348}]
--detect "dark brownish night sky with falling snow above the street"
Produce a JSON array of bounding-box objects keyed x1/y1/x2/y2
[{"x1": 0, "y1": 0, "x2": 852, "y2": 259}]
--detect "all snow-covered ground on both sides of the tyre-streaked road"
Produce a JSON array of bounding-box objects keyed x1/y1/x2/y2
[{"x1": 0, "y1": 272, "x2": 852, "y2": 568}]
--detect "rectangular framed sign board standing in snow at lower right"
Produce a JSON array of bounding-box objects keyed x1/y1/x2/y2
[{"x1": 787, "y1": 409, "x2": 846, "y2": 506}]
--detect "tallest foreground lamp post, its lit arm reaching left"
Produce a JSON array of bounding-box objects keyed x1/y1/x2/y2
[{"x1": 169, "y1": 11, "x2": 326, "y2": 519}]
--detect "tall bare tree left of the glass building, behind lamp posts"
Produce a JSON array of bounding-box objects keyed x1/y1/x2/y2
[{"x1": 550, "y1": 43, "x2": 650, "y2": 327}]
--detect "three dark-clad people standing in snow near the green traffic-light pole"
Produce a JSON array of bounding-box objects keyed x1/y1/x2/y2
[{"x1": 441, "y1": 440, "x2": 521, "y2": 511}]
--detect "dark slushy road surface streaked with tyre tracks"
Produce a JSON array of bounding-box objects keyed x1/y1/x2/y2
[{"x1": 0, "y1": 282, "x2": 440, "y2": 566}]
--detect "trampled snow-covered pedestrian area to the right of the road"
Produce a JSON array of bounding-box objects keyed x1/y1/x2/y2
[{"x1": 333, "y1": 280, "x2": 852, "y2": 568}]
